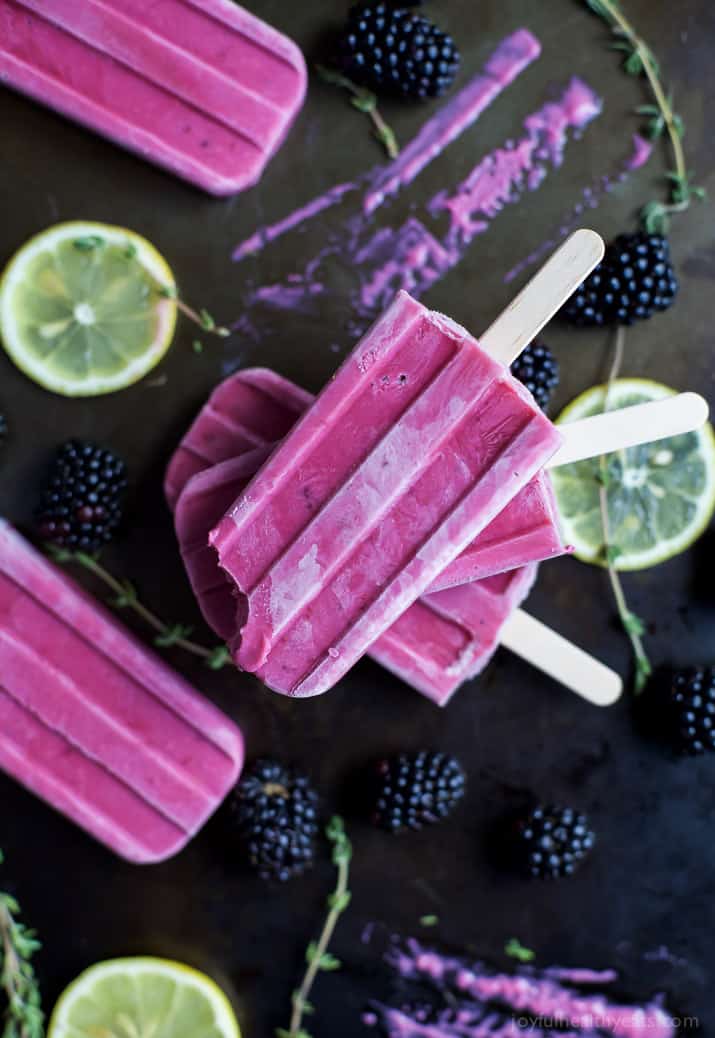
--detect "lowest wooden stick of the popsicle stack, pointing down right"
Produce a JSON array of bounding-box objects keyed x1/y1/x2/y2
[{"x1": 499, "y1": 609, "x2": 623, "y2": 707}]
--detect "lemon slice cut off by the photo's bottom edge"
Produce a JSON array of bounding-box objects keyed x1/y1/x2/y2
[{"x1": 48, "y1": 958, "x2": 241, "y2": 1038}]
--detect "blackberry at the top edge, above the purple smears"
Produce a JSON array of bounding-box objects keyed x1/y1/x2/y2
[{"x1": 338, "y1": 3, "x2": 460, "y2": 101}]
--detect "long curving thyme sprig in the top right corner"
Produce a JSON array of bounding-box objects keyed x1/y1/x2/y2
[{"x1": 585, "y1": 0, "x2": 706, "y2": 234}]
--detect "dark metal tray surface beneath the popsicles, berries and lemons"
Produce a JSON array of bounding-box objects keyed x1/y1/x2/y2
[{"x1": 0, "y1": 0, "x2": 715, "y2": 1038}]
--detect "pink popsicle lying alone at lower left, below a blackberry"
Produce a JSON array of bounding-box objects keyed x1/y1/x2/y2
[{"x1": 0, "y1": 519, "x2": 244, "y2": 864}]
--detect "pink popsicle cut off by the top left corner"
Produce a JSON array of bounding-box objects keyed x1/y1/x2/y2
[{"x1": 0, "y1": 0, "x2": 307, "y2": 195}]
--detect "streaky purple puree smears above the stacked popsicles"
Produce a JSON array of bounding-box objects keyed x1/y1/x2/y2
[{"x1": 233, "y1": 29, "x2": 650, "y2": 350}]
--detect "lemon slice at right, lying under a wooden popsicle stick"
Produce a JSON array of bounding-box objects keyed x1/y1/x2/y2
[{"x1": 551, "y1": 379, "x2": 715, "y2": 570}]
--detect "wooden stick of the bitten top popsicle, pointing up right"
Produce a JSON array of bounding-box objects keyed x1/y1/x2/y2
[{"x1": 479, "y1": 227, "x2": 605, "y2": 367}]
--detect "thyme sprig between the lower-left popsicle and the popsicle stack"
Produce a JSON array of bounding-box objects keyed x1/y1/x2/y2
[{"x1": 46, "y1": 544, "x2": 231, "y2": 668}]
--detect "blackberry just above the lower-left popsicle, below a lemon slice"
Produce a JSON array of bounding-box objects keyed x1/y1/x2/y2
[{"x1": 35, "y1": 440, "x2": 127, "y2": 551}]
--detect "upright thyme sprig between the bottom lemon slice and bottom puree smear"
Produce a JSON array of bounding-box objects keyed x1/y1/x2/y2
[{"x1": 276, "y1": 816, "x2": 353, "y2": 1038}]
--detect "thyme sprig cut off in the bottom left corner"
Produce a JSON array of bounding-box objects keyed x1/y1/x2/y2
[{"x1": 0, "y1": 851, "x2": 45, "y2": 1038}]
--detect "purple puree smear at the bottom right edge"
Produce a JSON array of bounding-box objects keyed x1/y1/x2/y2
[{"x1": 363, "y1": 939, "x2": 677, "y2": 1038}]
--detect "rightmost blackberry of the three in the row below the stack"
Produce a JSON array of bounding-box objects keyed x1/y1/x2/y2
[{"x1": 508, "y1": 804, "x2": 596, "y2": 879}]
